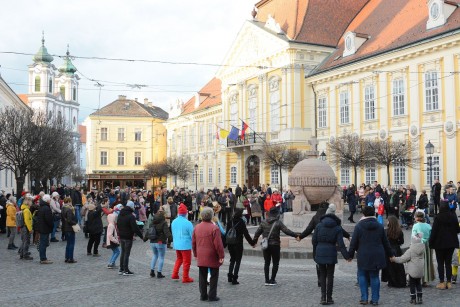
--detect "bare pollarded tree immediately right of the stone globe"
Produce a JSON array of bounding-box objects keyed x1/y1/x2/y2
[{"x1": 328, "y1": 134, "x2": 371, "y2": 186}]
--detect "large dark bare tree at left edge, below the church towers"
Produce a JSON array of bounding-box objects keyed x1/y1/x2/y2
[{"x1": 0, "y1": 108, "x2": 75, "y2": 195}]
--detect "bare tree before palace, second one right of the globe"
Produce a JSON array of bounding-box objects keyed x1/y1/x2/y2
[{"x1": 368, "y1": 139, "x2": 421, "y2": 185}]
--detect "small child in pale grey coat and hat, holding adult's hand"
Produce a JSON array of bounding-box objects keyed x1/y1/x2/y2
[{"x1": 390, "y1": 233, "x2": 425, "y2": 305}]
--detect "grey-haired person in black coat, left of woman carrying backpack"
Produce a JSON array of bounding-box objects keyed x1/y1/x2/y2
[{"x1": 117, "y1": 200, "x2": 144, "y2": 276}]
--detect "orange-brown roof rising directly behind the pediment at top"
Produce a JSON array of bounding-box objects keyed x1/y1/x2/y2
[{"x1": 256, "y1": 0, "x2": 369, "y2": 47}]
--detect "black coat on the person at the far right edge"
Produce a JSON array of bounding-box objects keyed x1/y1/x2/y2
[{"x1": 429, "y1": 206, "x2": 460, "y2": 249}]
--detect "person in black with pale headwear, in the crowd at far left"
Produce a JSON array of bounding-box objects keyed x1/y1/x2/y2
[{"x1": 36, "y1": 194, "x2": 54, "y2": 264}]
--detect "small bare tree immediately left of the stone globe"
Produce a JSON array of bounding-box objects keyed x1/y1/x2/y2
[{"x1": 263, "y1": 144, "x2": 306, "y2": 192}]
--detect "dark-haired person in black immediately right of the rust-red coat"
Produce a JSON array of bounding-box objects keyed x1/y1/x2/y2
[{"x1": 226, "y1": 208, "x2": 255, "y2": 285}]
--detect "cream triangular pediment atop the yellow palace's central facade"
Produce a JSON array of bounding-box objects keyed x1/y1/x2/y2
[{"x1": 216, "y1": 21, "x2": 289, "y2": 83}]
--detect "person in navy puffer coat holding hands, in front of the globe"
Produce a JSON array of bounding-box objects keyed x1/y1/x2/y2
[{"x1": 312, "y1": 214, "x2": 348, "y2": 305}]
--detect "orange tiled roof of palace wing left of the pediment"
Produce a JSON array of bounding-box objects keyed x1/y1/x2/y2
[{"x1": 181, "y1": 77, "x2": 222, "y2": 115}]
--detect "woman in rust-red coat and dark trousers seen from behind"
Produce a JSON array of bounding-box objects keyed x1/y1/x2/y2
[{"x1": 192, "y1": 207, "x2": 225, "y2": 302}]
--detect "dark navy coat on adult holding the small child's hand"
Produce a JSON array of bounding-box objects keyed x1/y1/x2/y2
[{"x1": 348, "y1": 217, "x2": 394, "y2": 271}]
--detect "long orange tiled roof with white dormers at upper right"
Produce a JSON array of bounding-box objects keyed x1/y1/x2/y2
[{"x1": 315, "y1": 0, "x2": 460, "y2": 74}]
